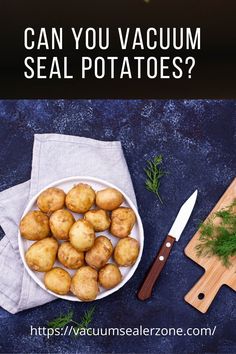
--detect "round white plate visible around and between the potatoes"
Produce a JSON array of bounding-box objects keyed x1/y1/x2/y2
[{"x1": 18, "y1": 176, "x2": 144, "y2": 301}]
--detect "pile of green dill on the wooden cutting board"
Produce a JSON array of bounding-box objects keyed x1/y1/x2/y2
[{"x1": 196, "y1": 200, "x2": 236, "y2": 267}]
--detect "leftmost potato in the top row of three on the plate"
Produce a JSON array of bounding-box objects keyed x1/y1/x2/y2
[{"x1": 37, "y1": 187, "x2": 66, "y2": 213}]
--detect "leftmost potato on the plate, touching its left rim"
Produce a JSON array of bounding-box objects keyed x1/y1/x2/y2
[{"x1": 20, "y1": 210, "x2": 50, "y2": 241}]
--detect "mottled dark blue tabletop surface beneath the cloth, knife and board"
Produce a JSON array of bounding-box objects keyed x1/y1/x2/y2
[{"x1": 0, "y1": 100, "x2": 236, "y2": 354}]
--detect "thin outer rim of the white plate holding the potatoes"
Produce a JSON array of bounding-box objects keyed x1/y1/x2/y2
[{"x1": 18, "y1": 176, "x2": 144, "y2": 302}]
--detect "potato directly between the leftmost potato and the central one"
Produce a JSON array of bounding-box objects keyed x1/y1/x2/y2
[{"x1": 49, "y1": 209, "x2": 75, "y2": 240}]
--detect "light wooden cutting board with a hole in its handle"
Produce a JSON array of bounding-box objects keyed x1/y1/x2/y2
[{"x1": 184, "y1": 178, "x2": 236, "y2": 313}]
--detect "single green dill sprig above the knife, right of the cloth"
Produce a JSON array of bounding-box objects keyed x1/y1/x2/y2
[{"x1": 144, "y1": 155, "x2": 166, "y2": 203}]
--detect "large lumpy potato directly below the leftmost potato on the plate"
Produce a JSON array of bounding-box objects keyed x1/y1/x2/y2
[{"x1": 25, "y1": 237, "x2": 58, "y2": 272}]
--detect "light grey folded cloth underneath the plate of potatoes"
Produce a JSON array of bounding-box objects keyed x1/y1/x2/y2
[{"x1": 0, "y1": 134, "x2": 136, "y2": 313}]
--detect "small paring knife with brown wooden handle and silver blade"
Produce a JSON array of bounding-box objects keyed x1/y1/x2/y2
[{"x1": 137, "y1": 190, "x2": 198, "y2": 300}]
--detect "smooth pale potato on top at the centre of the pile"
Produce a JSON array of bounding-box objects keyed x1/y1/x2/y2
[{"x1": 69, "y1": 219, "x2": 95, "y2": 252}]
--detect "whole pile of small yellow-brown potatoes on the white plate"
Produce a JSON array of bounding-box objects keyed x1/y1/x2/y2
[{"x1": 20, "y1": 183, "x2": 139, "y2": 301}]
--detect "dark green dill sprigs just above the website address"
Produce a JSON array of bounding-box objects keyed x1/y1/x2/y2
[{"x1": 48, "y1": 306, "x2": 95, "y2": 336}]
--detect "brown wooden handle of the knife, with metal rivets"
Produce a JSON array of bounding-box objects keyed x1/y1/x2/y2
[{"x1": 137, "y1": 235, "x2": 175, "y2": 300}]
